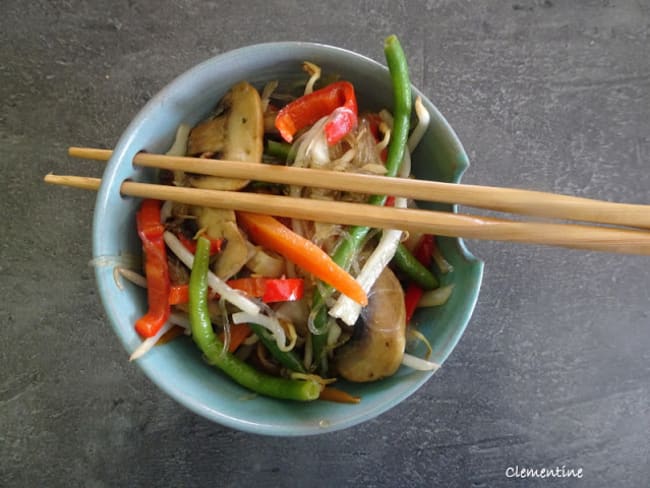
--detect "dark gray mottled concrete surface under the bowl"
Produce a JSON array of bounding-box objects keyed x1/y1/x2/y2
[{"x1": 0, "y1": 0, "x2": 650, "y2": 488}]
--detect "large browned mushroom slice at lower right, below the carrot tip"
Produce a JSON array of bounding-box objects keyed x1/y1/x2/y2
[{"x1": 334, "y1": 268, "x2": 406, "y2": 382}]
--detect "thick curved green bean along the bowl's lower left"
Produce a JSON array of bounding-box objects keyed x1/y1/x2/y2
[{"x1": 189, "y1": 237, "x2": 321, "y2": 401}]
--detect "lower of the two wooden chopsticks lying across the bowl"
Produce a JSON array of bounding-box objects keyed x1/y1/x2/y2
[{"x1": 45, "y1": 174, "x2": 650, "y2": 255}]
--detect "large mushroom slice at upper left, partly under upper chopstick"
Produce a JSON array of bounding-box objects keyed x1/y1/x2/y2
[{"x1": 187, "y1": 81, "x2": 264, "y2": 190}]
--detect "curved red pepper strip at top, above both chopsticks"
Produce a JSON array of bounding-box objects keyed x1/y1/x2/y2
[{"x1": 275, "y1": 81, "x2": 358, "y2": 146}]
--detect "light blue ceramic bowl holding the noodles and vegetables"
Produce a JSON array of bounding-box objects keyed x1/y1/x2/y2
[{"x1": 93, "y1": 42, "x2": 483, "y2": 436}]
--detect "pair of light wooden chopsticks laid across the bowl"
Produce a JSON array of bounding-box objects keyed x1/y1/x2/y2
[{"x1": 45, "y1": 147, "x2": 650, "y2": 255}]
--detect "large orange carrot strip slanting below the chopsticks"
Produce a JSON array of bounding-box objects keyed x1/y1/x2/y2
[{"x1": 237, "y1": 212, "x2": 368, "y2": 306}]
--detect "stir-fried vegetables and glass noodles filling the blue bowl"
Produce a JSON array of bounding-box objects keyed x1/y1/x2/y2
[{"x1": 122, "y1": 36, "x2": 453, "y2": 403}]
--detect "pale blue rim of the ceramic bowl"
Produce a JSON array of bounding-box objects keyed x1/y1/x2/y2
[{"x1": 92, "y1": 41, "x2": 484, "y2": 436}]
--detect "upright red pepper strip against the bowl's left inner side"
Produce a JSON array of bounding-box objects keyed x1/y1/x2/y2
[{"x1": 135, "y1": 199, "x2": 171, "y2": 337}]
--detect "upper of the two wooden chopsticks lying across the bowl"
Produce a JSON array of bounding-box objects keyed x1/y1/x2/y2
[{"x1": 68, "y1": 147, "x2": 650, "y2": 228}]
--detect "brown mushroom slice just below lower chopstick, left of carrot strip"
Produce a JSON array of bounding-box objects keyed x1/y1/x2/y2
[{"x1": 192, "y1": 207, "x2": 249, "y2": 280}]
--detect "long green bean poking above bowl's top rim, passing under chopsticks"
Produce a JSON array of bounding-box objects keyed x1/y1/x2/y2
[{"x1": 312, "y1": 35, "x2": 412, "y2": 370}]
